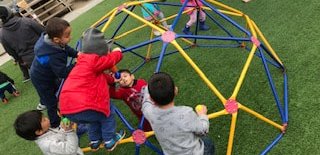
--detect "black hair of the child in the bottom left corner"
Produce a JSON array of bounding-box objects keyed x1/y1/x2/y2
[{"x1": 13, "y1": 110, "x2": 43, "y2": 140}]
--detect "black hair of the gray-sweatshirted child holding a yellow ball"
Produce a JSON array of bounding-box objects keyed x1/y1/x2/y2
[{"x1": 148, "y1": 72, "x2": 175, "y2": 106}]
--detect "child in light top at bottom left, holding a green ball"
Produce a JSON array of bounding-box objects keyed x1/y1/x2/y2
[{"x1": 14, "y1": 110, "x2": 83, "y2": 155}]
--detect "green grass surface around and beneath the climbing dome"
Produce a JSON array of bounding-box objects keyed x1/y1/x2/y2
[{"x1": 0, "y1": 0, "x2": 320, "y2": 155}]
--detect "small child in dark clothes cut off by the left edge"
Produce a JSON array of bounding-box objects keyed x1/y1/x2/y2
[{"x1": 0, "y1": 71, "x2": 19, "y2": 104}]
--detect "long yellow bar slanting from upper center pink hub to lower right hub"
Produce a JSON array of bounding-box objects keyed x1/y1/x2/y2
[{"x1": 171, "y1": 40, "x2": 226, "y2": 104}]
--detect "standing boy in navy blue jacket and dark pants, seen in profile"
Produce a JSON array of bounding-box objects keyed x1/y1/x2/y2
[{"x1": 30, "y1": 18, "x2": 78, "y2": 128}]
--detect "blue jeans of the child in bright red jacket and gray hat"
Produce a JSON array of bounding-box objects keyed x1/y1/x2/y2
[{"x1": 65, "y1": 108, "x2": 116, "y2": 142}]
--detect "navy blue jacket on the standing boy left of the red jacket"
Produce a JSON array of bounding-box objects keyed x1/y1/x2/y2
[{"x1": 30, "y1": 33, "x2": 78, "y2": 84}]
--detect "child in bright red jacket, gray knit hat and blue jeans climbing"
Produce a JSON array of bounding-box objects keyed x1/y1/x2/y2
[{"x1": 60, "y1": 28, "x2": 125, "y2": 151}]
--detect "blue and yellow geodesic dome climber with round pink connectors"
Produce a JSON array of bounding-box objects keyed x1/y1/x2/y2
[{"x1": 79, "y1": 0, "x2": 288, "y2": 155}]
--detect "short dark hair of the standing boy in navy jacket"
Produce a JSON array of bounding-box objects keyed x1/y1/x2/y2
[{"x1": 46, "y1": 17, "x2": 70, "y2": 39}]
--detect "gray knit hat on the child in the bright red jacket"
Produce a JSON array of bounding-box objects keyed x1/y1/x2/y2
[{"x1": 81, "y1": 28, "x2": 113, "y2": 56}]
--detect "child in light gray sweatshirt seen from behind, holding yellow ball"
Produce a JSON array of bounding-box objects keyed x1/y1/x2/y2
[{"x1": 142, "y1": 72, "x2": 214, "y2": 155}]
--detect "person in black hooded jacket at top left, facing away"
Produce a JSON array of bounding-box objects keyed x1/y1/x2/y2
[{"x1": 0, "y1": 6, "x2": 44, "y2": 82}]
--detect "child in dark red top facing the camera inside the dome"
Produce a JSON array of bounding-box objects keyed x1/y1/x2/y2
[{"x1": 110, "y1": 69, "x2": 152, "y2": 131}]
